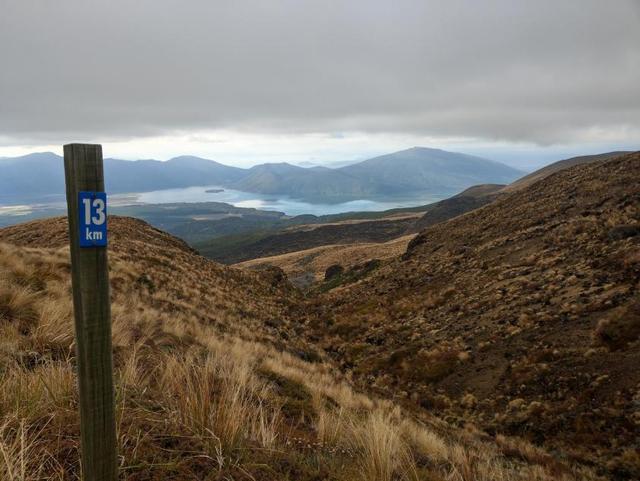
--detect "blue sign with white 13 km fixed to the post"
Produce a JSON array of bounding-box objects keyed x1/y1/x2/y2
[{"x1": 78, "y1": 192, "x2": 107, "y2": 247}]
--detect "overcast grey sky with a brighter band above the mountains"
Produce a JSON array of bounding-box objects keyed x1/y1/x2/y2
[{"x1": 0, "y1": 0, "x2": 640, "y2": 167}]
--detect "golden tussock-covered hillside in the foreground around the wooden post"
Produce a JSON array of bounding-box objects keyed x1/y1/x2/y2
[{"x1": 0, "y1": 218, "x2": 598, "y2": 481}]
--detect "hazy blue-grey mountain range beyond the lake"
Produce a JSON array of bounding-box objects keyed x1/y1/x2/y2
[{"x1": 0, "y1": 147, "x2": 523, "y2": 203}]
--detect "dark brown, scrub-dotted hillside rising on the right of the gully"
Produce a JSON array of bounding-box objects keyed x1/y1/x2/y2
[{"x1": 307, "y1": 153, "x2": 640, "y2": 479}]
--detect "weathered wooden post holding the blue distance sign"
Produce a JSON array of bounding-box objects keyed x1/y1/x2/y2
[{"x1": 64, "y1": 144, "x2": 117, "y2": 481}]
